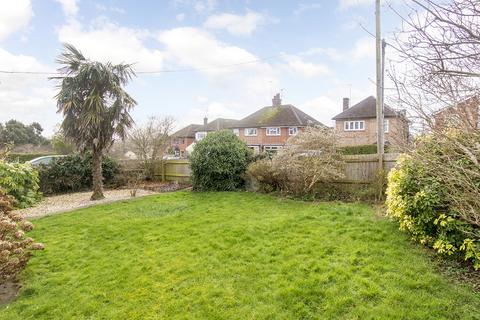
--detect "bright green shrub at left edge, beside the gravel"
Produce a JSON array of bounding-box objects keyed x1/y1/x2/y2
[{"x1": 0, "y1": 160, "x2": 40, "y2": 208}]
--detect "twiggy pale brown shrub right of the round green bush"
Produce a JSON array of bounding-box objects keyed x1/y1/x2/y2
[{"x1": 247, "y1": 128, "x2": 344, "y2": 197}]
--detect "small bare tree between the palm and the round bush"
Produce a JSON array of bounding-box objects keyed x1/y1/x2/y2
[{"x1": 129, "y1": 116, "x2": 175, "y2": 178}]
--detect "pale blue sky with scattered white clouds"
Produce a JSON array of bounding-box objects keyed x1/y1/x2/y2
[{"x1": 0, "y1": 0, "x2": 401, "y2": 136}]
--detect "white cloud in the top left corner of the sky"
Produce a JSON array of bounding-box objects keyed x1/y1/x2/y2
[{"x1": 0, "y1": 0, "x2": 33, "y2": 41}]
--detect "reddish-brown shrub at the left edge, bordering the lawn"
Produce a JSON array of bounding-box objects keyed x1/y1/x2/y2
[{"x1": 0, "y1": 190, "x2": 43, "y2": 283}]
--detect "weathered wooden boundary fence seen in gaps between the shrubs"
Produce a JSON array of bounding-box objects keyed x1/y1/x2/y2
[{"x1": 123, "y1": 153, "x2": 399, "y2": 184}]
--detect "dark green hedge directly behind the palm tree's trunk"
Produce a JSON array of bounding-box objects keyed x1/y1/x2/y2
[{"x1": 38, "y1": 153, "x2": 120, "y2": 194}]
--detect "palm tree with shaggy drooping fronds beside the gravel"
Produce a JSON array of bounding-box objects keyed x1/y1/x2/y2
[{"x1": 55, "y1": 44, "x2": 137, "y2": 200}]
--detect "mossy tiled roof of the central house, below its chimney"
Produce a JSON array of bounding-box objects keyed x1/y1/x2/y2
[{"x1": 235, "y1": 104, "x2": 323, "y2": 128}]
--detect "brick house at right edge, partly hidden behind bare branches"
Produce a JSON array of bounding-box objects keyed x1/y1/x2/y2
[{"x1": 433, "y1": 97, "x2": 480, "y2": 129}]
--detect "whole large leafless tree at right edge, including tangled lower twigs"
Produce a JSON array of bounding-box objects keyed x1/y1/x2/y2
[{"x1": 390, "y1": 0, "x2": 480, "y2": 245}]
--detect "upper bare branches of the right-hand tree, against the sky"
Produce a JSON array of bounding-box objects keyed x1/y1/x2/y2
[{"x1": 389, "y1": 0, "x2": 480, "y2": 130}]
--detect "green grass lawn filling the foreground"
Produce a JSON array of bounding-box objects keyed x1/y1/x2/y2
[{"x1": 0, "y1": 192, "x2": 480, "y2": 320}]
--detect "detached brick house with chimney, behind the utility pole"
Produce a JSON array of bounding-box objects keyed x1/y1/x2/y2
[{"x1": 333, "y1": 96, "x2": 409, "y2": 147}]
